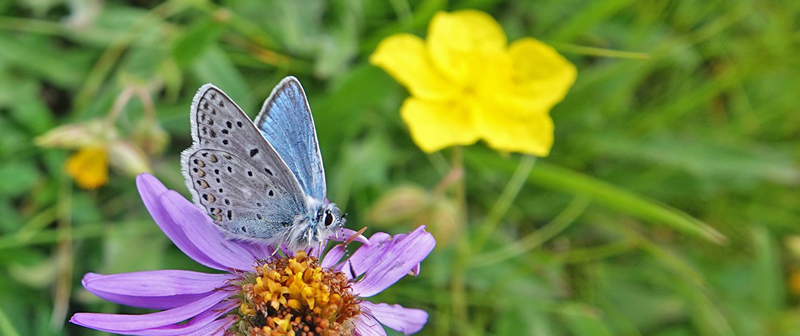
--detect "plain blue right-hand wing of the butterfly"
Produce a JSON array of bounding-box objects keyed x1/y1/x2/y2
[{"x1": 255, "y1": 76, "x2": 326, "y2": 200}]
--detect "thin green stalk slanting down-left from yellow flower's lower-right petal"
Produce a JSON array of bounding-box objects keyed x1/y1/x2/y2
[{"x1": 472, "y1": 155, "x2": 536, "y2": 251}]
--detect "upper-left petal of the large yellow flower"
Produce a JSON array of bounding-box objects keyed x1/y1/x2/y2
[{"x1": 369, "y1": 34, "x2": 456, "y2": 100}]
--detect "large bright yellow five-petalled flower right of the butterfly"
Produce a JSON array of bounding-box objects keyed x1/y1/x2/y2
[{"x1": 370, "y1": 10, "x2": 576, "y2": 156}]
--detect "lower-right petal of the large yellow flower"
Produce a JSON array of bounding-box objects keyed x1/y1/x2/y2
[{"x1": 475, "y1": 102, "x2": 553, "y2": 156}]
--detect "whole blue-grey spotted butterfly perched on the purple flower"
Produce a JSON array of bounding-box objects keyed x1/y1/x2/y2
[{"x1": 181, "y1": 77, "x2": 345, "y2": 250}]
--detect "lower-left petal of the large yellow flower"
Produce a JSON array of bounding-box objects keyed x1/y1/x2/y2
[{"x1": 400, "y1": 97, "x2": 478, "y2": 153}]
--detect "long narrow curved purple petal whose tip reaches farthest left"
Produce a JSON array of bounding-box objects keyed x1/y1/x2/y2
[{"x1": 69, "y1": 291, "x2": 231, "y2": 334}]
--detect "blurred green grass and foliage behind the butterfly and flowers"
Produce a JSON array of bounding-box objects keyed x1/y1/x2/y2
[{"x1": 0, "y1": 0, "x2": 800, "y2": 336}]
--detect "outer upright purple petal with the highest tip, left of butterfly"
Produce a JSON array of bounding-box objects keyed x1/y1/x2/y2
[{"x1": 136, "y1": 173, "x2": 228, "y2": 270}]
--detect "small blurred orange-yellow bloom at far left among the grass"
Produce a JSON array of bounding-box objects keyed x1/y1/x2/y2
[{"x1": 66, "y1": 147, "x2": 108, "y2": 189}]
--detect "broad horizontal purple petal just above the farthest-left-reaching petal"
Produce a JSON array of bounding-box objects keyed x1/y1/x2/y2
[{"x1": 82, "y1": 270, "x2": 233, "y2": 309}]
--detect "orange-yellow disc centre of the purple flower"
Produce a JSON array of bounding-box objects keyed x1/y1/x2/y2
[{"x1": 231, "y1": 251, "x2": 361, "y2": 336}]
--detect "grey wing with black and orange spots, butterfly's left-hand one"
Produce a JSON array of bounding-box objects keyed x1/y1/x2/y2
[{"x1": 181, "y1": 84, "x2": 306, "y2": 241}]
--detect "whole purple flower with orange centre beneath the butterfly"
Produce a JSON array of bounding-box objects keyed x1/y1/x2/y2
[{"x1": 70, "y1": 174, "x2": 436, "y2": 336}]
